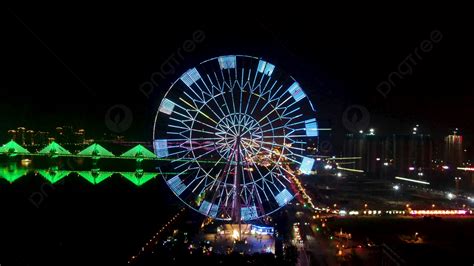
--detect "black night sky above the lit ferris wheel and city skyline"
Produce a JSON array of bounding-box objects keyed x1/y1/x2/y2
[{"x1": 0, "y1": 6, "x2": 474, "y2": 140}]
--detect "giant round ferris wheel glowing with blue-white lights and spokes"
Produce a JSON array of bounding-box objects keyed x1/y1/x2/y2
[{"x1": 153, "y1": 55, "x2": 318, "y2": 222}]
